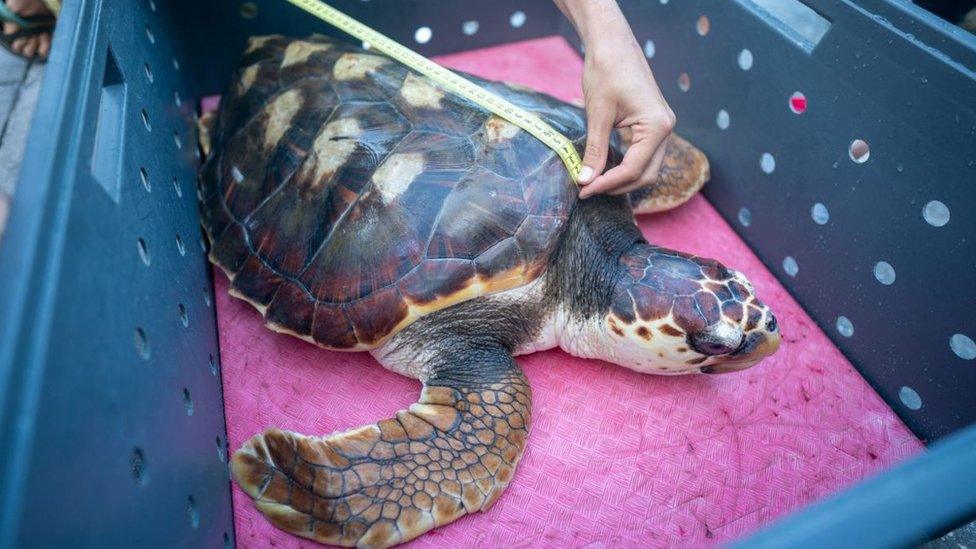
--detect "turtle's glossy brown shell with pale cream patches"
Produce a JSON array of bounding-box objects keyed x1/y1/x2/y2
[{"x1": 202, "y1": 36, "x2": 586, "y2": 349}]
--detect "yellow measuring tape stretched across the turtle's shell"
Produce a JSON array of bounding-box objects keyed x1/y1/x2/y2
[{"x1": 288, "y1": 0, "x2": 583, "y2": 181}]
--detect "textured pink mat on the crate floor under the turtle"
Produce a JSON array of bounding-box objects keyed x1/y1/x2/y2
[{"x1": 215, "y1": 37, "x2": 922, "y2": 547}]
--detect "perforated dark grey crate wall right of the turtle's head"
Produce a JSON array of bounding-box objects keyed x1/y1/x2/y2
[{"x1": 600, "y1": 0, "x2": 976, "y2": 440}]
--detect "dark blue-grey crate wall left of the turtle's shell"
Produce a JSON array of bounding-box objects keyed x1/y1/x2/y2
[{"x1": 0, "y1": 0, "x2": 233, "y2": 547}]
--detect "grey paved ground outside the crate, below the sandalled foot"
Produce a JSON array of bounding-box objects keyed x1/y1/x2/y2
[{"x1": 0, "y1": 49, "x2": 44, "y2": 242}]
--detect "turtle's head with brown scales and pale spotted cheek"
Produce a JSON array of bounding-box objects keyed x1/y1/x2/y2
[{"x1": 605, "y1": 244, "x2": 780, "y2": 374}]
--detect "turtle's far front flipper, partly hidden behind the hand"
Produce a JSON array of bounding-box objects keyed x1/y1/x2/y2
[{"x1": 630, "y1": 134, "x2": 709, "y2": 215}]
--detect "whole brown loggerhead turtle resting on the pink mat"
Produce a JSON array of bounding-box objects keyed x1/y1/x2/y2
[{"x1": 201, "y1": 36, "x2": 779, "y2": 546}]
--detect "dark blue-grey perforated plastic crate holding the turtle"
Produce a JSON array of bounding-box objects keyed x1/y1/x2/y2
[{"x1": 0, "y1": 0, "x2": 976, "y2": 547}]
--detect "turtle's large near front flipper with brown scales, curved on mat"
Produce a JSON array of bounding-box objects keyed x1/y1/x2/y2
[{"x1": 231, "y1": 348, "x2": 531, "y2": 547}]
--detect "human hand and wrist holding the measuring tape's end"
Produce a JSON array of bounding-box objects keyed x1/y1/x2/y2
[{"x1": 556, "y1": 0, "x2": 675, "y2": 198}]
